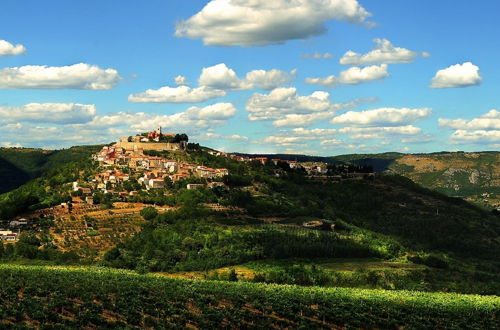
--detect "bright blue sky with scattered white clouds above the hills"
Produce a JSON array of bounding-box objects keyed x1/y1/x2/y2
[{"x1": 0, "y1": 0, "x2": 500, "y2": 155}]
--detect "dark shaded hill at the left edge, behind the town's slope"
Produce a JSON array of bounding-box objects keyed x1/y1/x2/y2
[{"x1": 0, "y1": 146, "x2": 100, "y2": 194}]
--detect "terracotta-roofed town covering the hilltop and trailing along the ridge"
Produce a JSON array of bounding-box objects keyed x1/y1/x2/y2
[{"x1": 0, "y1": 127, "x2": 373, "y2": 241}]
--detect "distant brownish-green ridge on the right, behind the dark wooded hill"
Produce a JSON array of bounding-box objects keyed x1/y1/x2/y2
[{"x1": 232, "y1": 151, "x2": 500, "y2": 207}]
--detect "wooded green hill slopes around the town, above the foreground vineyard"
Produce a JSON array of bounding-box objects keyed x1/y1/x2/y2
[{"x1": 0, "y1": 146, "x2": 500, "y2": 294}]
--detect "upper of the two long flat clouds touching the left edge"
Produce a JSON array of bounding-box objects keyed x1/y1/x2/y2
[{"x1": 0, "y1": 63, "x2": 121, "y2": 90}]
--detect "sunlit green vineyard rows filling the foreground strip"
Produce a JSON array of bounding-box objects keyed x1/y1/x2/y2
[{"x1": 0, "y1": 265, "x2": 500, "y2": 329}]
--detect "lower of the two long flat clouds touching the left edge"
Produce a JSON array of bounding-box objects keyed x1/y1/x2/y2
[{"x1": 0, "y1": 103, "x2": 96, "y2": 124}]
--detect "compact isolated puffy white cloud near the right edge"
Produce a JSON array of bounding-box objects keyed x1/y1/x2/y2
[{"x1": 430, "y1": 62, "x2": 482, "y2": 88}]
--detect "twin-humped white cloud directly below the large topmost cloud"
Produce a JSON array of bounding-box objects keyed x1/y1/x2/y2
[{"x1": 198, "y1": 63, "x2": 296, "y2": 90}]
